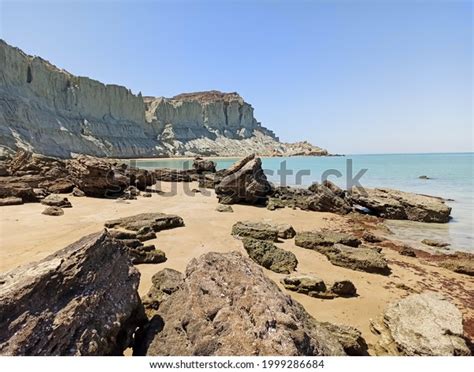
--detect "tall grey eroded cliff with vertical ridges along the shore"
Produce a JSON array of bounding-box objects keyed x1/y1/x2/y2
[{"x1": 0, "y1": 40, "x2": 326, "y2": 158}]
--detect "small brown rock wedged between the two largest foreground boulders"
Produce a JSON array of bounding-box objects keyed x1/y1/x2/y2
[{"x1": 142, "y1": 268, "x2": 184, "y2": 318}]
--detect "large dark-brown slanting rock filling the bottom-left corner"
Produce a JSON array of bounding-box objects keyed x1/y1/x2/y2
[{"x1": 0, "y1": 232, "x2": 144, "y2": 355}]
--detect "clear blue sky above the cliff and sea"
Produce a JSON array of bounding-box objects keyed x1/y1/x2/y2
[{"x1": 0, "y1": 0, "x2": 473, "y2": 153}]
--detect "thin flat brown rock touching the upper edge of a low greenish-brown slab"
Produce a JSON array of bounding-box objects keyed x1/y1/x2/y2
[{"x1": 295, "y1": 230, "x2": 361, "y2": 250}]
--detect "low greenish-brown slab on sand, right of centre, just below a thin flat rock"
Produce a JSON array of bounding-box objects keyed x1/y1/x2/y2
[{"x1": 321, "y1": 244, "x2": 390, "y2": 275}]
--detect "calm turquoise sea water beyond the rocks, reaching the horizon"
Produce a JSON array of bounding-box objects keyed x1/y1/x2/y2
[{"x1": 137, "y1": 153, "x2": 474, "y2": 251}]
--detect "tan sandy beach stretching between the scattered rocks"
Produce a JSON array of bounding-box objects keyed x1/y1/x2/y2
[{"x1": 0, "y1": 182, "x2": 474, "y2": 352}]
